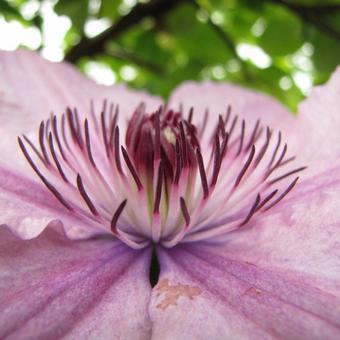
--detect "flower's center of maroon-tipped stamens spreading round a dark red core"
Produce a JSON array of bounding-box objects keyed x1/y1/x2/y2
[{"x1": 18, "y1": 101, "x2": 305, "y2": 249}]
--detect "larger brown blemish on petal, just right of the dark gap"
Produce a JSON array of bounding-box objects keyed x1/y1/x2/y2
[{"x1": 156, "y1": 279, "x2": 202, "y2": 310}]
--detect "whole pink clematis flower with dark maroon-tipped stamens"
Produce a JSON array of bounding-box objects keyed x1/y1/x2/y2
[{"x1": 0, "y1": 51, "x2": 340, "y2": 339}]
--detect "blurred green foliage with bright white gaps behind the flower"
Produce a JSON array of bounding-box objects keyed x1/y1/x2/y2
[{"x1": 0, "y1": 0, "x2": 340, "y2": 110}]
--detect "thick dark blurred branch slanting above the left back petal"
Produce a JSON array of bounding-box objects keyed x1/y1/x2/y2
[{"x1": 65, "y1": 0, "x2": 183, "y2": 62}]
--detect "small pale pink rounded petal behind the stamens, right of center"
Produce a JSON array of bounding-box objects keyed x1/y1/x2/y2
[{"x1": 170, "y1": 82, "x2": 296, "y2": 145}]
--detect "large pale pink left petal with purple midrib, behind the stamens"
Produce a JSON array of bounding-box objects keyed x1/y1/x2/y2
[{"x1": 0, "y1": 50, "x2": 161, "y2": 238}]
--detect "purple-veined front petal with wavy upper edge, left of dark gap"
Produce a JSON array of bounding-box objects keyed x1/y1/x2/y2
[{"x1": 0, "y1": 223, "x2": 151, "y2": 339}]
